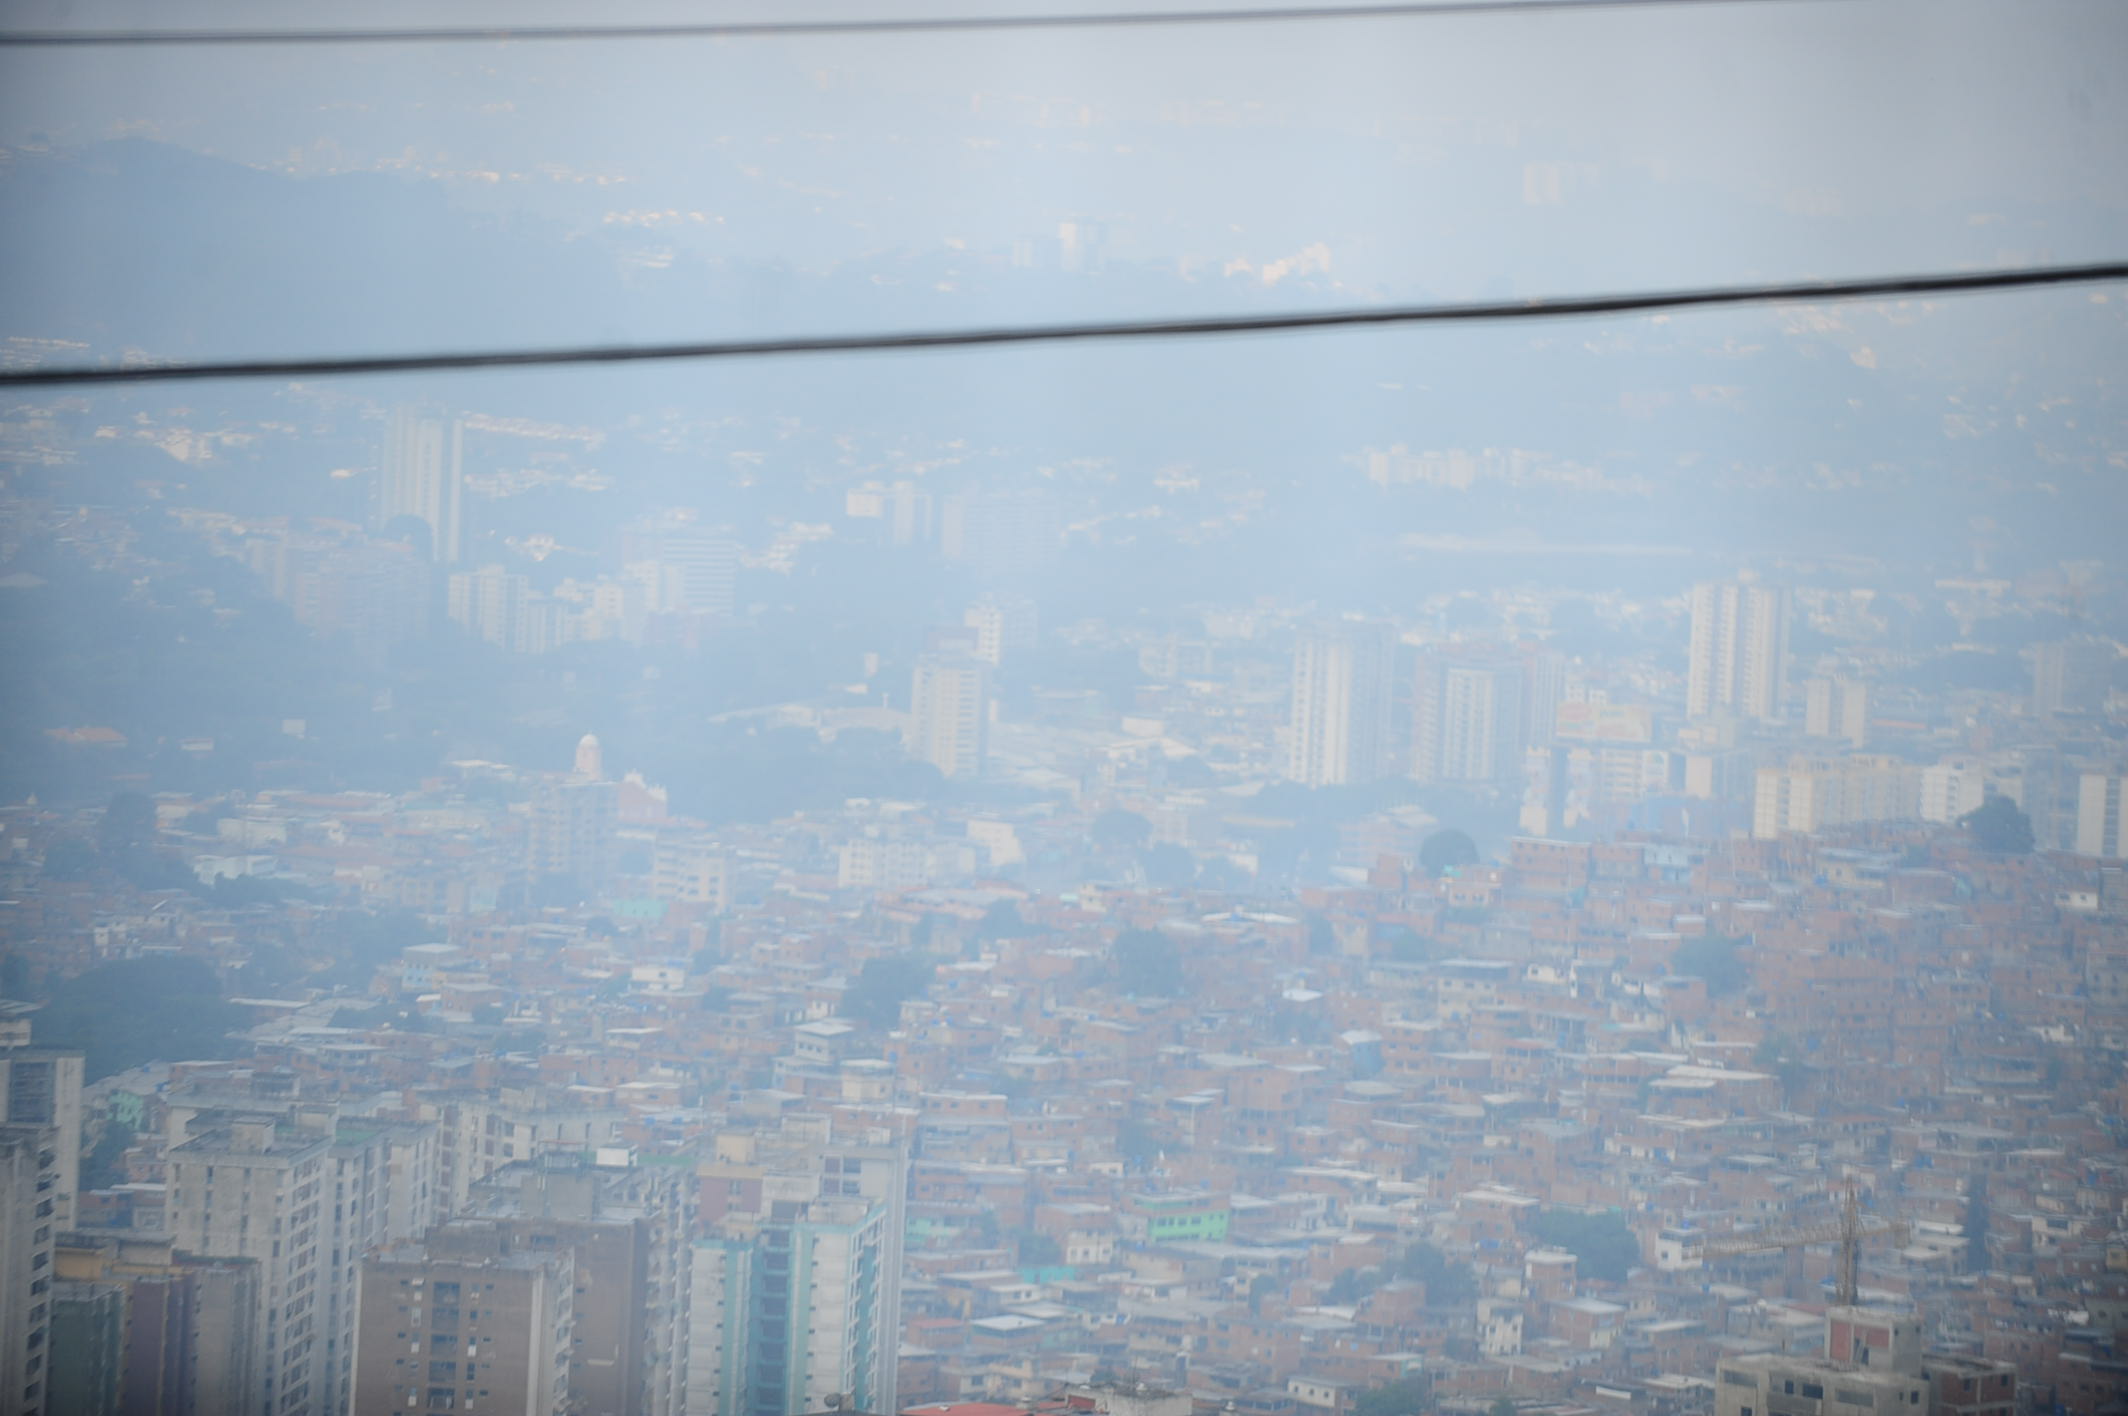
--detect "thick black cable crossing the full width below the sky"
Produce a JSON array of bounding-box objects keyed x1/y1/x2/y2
[{"x1": 0, "y1": 260, "x2": 2128, "y2": 388}]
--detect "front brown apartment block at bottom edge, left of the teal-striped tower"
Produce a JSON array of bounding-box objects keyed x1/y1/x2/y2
[{"x1": 349, "y1": 1220, "x2": 577, "y2": 1416}]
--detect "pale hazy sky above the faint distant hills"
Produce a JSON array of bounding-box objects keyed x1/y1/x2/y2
[{"x1": 0, "y1": 0, "x2": 2128, "y2": 304}]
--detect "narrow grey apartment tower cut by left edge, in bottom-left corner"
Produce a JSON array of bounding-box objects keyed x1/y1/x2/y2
[{"x1": 0, "y1": 1124, "x2": 60, "y2": 1416}]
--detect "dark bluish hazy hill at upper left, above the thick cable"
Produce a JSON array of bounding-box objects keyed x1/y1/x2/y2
[{"x1": 0, "y1": 141, "x2": 663, "y2": 356}]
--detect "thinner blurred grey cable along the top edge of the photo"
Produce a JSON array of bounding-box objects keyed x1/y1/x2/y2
[{"x1": 0, "y1": 0, "x2": 1830, "y2": 49}]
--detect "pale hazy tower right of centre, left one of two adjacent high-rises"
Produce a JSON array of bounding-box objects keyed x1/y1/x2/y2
[{"x1": 1285, "y1": 622, "x2": 1396, "y2": 786}]
